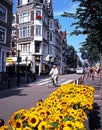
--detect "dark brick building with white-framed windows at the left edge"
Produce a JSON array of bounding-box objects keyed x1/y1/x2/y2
[{"x1": 0, "y1": 0, "x2": 12, "y2": 81}]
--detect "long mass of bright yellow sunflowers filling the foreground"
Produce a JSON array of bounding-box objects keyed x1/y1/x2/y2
[{"x1": 1, "y1": 84, "x2": 94, "y2": 130}]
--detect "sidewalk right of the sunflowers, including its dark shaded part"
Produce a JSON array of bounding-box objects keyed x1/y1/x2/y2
[{"x1": 84, "y1": 77, "x2": 102, "y2": 130}]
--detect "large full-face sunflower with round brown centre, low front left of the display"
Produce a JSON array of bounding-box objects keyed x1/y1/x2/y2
[{"x1": 28, "y1": 114, "x2": 39, "y2": 127}]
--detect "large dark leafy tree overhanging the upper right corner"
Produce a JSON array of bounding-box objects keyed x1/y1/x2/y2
[{"x1": 62, "y1": 0, "x2": 102, "y2": 98}]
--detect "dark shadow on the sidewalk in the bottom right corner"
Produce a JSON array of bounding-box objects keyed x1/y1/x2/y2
[{"x1": 89, "y1": 103, "x2": 101, "y2": 130}]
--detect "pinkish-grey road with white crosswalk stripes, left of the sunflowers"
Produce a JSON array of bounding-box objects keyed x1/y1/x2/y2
[{"x1": 0, "y1": 74, "x2": 81, "y2": 122}]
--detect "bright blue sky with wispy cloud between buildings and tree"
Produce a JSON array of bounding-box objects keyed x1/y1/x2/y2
[{"x1": 13, "y1": 0, "x2": 86, "y2": 56}]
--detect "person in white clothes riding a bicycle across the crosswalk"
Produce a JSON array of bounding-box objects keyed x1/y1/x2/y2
[{"x1": 49, "y1": 64, "x2": 58, "y2": 86}]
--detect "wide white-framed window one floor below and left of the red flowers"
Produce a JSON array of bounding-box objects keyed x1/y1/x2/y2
[{"x1": 19, "y1": 27, "x2": 30, "y2": 38}]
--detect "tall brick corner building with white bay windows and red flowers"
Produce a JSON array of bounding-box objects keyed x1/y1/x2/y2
[{"x1": 13, "y1": 0, "x2": 62, "y2": 74}]
